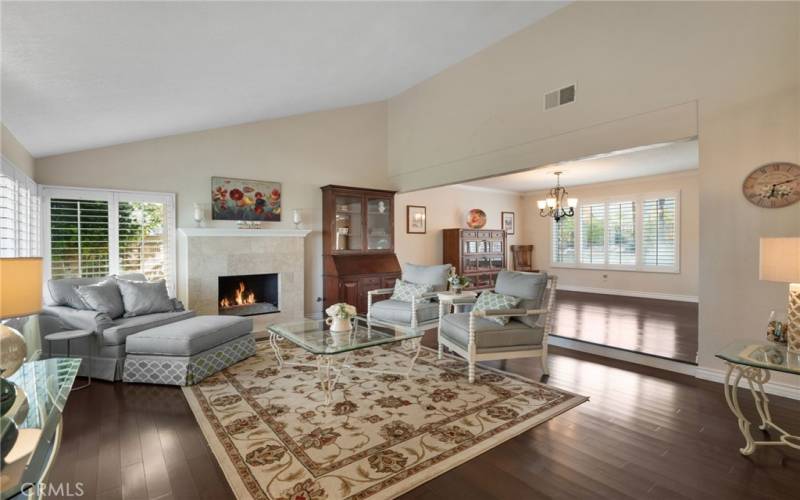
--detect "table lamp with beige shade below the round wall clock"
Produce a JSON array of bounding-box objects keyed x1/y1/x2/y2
[{"x1": 758, "y1": 237, "x2": 800, "y2": 353}]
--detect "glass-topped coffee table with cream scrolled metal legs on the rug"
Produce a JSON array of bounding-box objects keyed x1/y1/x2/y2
[{"x1": 267, "y1": 316, "x2": 425, "y2": 404}]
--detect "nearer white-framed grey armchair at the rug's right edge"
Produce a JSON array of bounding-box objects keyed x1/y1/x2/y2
[{"x1": 438, "y1": 271, "x2": 558, "y2": 383}]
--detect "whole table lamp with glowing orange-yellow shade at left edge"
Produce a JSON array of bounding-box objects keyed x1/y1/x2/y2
[{"x1": 0, "y1": 257, "x2": 42, "y2": 412}]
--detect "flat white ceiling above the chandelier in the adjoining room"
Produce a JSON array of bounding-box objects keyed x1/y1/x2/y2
[{"x1": 463, "y1": 140, "x2": 700, "y2": 193}]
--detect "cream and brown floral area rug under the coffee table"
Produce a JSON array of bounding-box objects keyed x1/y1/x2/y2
[{"x1": 183, "y1": 341, "x2": 587, "y2": 500}]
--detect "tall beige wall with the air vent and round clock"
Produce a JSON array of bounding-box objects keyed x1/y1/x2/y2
[{"x1": 388, "y1": 2, "x2": 800, "y2": 378}]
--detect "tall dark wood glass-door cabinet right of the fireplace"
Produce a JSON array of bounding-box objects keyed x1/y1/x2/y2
[{"x1": 322, "y1": 185, "x2": 400, "y2": 315}]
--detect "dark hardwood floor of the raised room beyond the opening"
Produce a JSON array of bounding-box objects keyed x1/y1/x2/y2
[{"x1": 554, "y1": 290, "x2": 698, "y2": 363}]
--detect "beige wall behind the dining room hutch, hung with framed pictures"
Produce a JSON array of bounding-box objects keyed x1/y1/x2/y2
[{"x1": 394, "y1": 186, "x2": 524, "y2": 264}]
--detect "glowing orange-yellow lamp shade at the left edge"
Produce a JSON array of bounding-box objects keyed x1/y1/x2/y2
[{"x1": 0, "y1": 257, "x2": 42, "y2": 319}]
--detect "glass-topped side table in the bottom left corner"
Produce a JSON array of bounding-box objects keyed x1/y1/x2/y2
[{"x1": 0, "y1": 358, "x2": 81, "y2": 500}]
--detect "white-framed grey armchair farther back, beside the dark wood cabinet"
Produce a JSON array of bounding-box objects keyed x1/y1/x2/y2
[{"x1": 367, "y1": 264, "x2": 451, "y2": 328}]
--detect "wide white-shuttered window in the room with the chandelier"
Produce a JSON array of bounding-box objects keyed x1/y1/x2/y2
[{"x1": 552, "y1": 193, "x2": 680, "y2": 272}]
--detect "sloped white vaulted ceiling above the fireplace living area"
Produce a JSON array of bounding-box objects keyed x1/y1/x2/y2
[{"x1": 1, "y1": 1, "x2": 566, "y2": 157}]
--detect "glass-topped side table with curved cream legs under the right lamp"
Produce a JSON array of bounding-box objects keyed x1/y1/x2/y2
[{"x1": 717, "y1": 341, "x2": 800, "y2": 455}]
